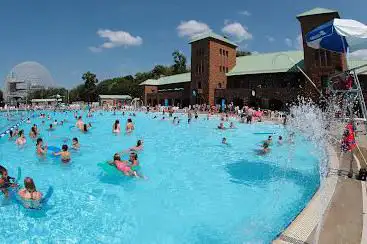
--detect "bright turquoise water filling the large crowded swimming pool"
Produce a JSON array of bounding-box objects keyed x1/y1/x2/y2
[{"x1": 0, "y1": 113, "x2": 319, "y2": 244}]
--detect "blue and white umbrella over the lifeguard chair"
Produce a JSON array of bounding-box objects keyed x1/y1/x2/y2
[{"x1": 305, "y1": 19, "x2": 367, "y2": 53}]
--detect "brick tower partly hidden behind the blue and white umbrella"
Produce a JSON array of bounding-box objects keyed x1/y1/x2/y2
[{"x1": 297, "y1": 8, "x2": 346, "y2": 100}]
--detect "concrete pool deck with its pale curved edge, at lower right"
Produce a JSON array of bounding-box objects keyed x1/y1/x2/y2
[{"x1": 273, "y1": 127, "x2": 367, "y2": 244}]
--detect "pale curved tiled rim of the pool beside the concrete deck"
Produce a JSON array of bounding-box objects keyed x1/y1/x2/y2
[{"x1": 273, "y1": 145, "x2": 339, "y2": 244}]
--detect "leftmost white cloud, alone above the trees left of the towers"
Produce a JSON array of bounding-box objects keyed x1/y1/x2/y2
[{"x1": 89, "y1": 29, "x2": 143, "y2": 52}]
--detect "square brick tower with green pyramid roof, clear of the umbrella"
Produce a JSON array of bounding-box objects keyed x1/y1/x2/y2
[{"x1": 190, "y1": 33, "x2": 237, "y2": 105}]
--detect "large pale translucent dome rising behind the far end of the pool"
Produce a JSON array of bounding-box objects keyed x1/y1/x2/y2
[{"x1": 9, "y1": 61, "x2": 55, "y2": 87}]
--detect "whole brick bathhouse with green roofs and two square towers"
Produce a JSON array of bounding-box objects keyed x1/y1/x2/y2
[{"x1": 140, "y1": 8, "x2": 367, "y2": 109}]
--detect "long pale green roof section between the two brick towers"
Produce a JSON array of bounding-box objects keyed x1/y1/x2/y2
[{"x1": 227, "y1": 51, "x2": 303, "y2": 76}]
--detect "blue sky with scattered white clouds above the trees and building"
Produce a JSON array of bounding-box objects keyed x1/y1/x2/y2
[{"x1": 0, "y1": 0, "x2": 367, "y2": 88}]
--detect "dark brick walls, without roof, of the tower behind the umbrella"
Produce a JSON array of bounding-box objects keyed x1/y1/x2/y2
[{"x1": 299, "y1": 13, "x2": 346, "y2": 98}]
